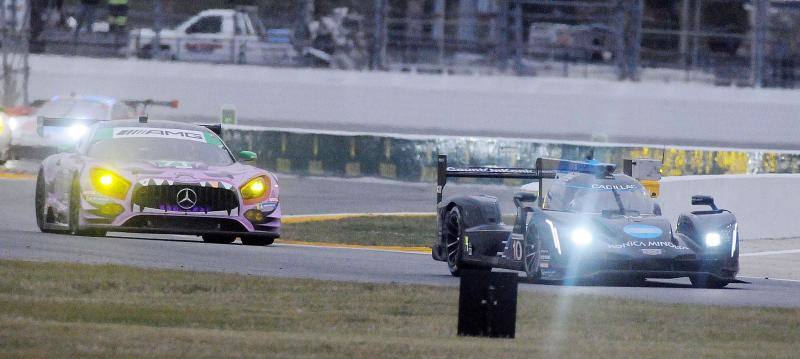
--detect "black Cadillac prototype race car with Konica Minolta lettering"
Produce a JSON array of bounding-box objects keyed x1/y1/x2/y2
[{"x1": 433, "y1": 156, "x2": 739, "y2": 288}]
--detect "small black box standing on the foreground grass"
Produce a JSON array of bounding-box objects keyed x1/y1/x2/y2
[{"x1": 458, "y1": 270, "x2": 519, "y2": 338}]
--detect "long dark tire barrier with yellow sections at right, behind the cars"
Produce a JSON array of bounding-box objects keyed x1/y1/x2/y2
[{"x1": 223, "y1": 126, "x2": 800, "y2": 184}]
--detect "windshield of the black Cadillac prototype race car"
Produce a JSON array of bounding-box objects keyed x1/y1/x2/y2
[{"x1": 543, "y1": 176, "x2": 653, "y2": 214}]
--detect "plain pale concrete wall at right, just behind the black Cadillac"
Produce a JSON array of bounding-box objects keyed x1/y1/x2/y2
[{"x1": 658, "y1": 174, "x2": 800, "y2": 239}]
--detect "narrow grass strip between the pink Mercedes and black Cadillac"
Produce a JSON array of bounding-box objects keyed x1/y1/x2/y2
[{"x1": 281, "y1": 216, "x2": 436, "y2": 247}]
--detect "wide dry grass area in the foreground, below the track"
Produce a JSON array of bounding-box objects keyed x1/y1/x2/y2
[{"x1": 0, "y1": 261, "x2": 800, "y2": 358}]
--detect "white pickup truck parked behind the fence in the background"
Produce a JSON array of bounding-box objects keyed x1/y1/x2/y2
[{"x1": 128, "y1": 9, "x2": 297, "y2": 65}]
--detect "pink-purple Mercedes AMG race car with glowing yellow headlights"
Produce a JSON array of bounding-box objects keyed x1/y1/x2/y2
[{"x1": 36, "y1": 117, "x2": 281, "y2": 245}]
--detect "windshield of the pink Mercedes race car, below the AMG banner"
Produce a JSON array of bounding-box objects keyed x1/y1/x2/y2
[{"x1": 88, "y1": 137, "x2": 234, "y2": 166}]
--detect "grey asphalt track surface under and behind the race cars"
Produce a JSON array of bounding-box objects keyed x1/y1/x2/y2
[{"x1": 0, "y1": 177, "x2": 800, "y2": 307}]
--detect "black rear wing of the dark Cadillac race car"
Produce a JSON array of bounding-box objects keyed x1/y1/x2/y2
[{"x1": 436, "y1": 155, "x2": 557, "y2": 205}]
